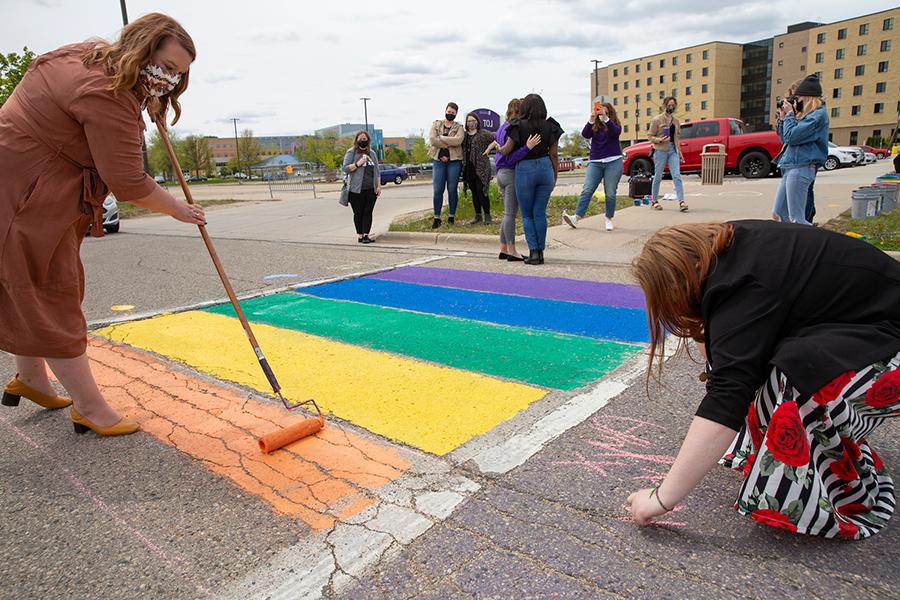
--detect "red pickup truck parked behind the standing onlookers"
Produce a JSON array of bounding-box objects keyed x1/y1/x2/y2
[{"x1": 624, "y1": 119, "x2": 781, "y2": 179}]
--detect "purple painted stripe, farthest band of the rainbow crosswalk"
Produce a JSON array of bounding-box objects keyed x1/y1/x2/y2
[{"x1": 369, "y1": 267, "x2": 644, "y2": 308}]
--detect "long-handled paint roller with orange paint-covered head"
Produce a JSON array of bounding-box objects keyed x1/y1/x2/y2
[{"x1": 154, "y1": 118, "x2": 325, "y2": 454}]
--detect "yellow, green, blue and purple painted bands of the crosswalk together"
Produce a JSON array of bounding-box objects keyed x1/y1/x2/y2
[{"x1": 95, "y1": 266, "x2": 648, "y2": 454}]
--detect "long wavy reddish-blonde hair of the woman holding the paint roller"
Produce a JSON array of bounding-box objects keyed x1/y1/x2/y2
[{"x1": 82, "y1": 13, "x2": 197, "y2": 125}]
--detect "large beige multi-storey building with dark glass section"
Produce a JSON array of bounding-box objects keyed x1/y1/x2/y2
[{"x1": 590, "y1": 8, "x2": 900, "y2": 144}]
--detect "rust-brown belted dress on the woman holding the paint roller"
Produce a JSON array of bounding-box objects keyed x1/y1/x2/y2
[{"x1": 0, "y1": 43, "x2": 156, "y2": 358}]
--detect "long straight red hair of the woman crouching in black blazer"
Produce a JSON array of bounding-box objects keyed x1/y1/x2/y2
[{"x1": 632, "y1": 223, "x2": 734, "y2": 381}]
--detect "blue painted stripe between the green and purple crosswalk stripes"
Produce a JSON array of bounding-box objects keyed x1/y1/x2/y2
[{"x1": 294, "y1": 278, "x2": 650, "y2": 342}]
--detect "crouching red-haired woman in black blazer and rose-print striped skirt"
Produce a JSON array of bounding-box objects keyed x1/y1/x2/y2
[{"x1": 628, "y1": 221, "x2": 900, "y2": 538}]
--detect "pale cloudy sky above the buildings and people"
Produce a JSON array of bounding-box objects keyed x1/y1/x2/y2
[{"x1": 0, "y1": 0, "x2": 896, "y2": 136}]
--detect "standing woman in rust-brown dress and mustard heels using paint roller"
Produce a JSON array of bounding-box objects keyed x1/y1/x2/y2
[{"x1": 0, "y1": 14, "x2": 204, "y2": 435}]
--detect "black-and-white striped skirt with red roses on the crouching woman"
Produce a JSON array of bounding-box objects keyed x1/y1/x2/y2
[{"x1": 720, "y1": 353, "x2": 900, "y2": 539}]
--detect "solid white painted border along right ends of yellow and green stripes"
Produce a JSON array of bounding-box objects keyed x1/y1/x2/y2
[{"x1": 472, "y1": 344, "x2": 675, "y2": 474}]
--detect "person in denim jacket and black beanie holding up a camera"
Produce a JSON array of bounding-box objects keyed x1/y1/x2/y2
[{"x1": 772, "y1": 75, "x2": 828, "y2": 225}]
